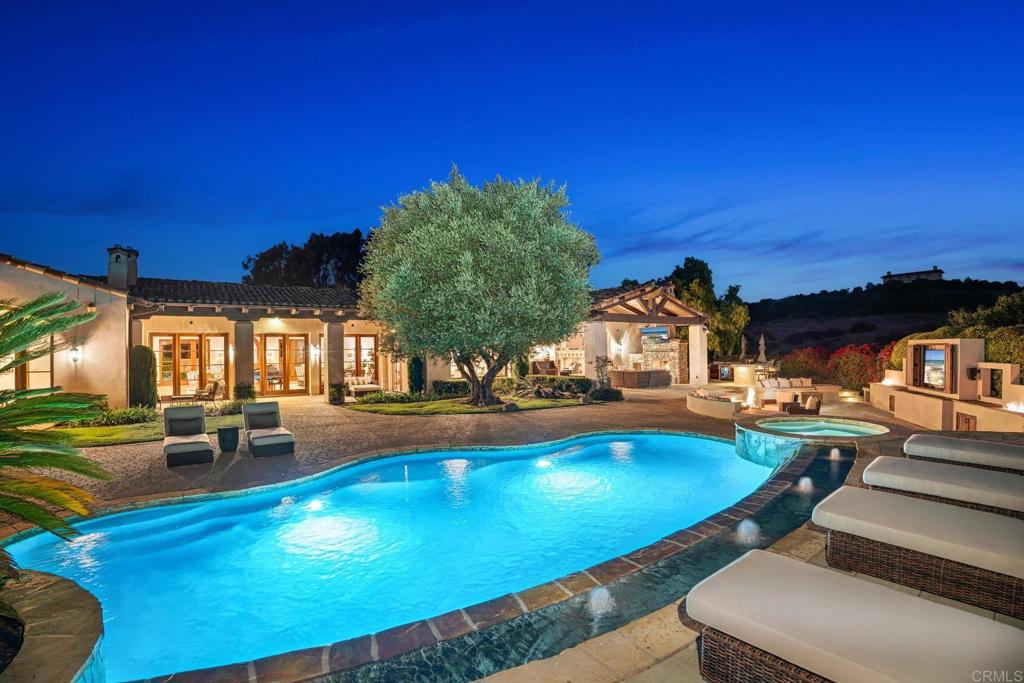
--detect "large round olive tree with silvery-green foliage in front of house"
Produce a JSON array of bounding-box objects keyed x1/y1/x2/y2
[{"x1": 359, "y1": 168, "x2": 600, "y2": 405}]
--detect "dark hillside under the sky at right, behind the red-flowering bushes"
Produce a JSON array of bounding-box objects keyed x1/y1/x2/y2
[{"x1": 746, "y1": 279, "x2": 1024, "y2": 356}]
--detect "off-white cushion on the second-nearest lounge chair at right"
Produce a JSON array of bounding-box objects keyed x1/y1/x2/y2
[{"x1": 811, "y1": 489, "x2": 1024, "y2": 579}]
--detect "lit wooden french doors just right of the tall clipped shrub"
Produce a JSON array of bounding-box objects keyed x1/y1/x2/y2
[{"x1": 150, "y1": 333, "x2": 227, "y2": 398}]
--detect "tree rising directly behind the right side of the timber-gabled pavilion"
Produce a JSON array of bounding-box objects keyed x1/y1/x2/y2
[{"x1": 669, "y1": 256, "x2": 751, "y2": 355}]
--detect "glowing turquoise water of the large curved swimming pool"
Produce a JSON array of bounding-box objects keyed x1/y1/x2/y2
[{"x1": 8, "y1": 433, "x2": 772, "y2": 682}]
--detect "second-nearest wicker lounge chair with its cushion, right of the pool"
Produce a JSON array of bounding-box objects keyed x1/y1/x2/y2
[{"x1": 811, "y1": 486, "x2": 1024, "y2": 618}]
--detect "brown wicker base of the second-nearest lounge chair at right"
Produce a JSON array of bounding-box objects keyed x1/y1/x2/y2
[{"x1": 825, "y1": 529, "x2": 1024, "y2": 618}]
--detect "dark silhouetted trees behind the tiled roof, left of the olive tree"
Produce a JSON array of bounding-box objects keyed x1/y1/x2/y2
[{"x1": 242, "y1": 229, "x2": 366, "y2": 287}]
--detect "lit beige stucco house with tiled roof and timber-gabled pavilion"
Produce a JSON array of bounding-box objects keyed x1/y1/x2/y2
[{"x1": 0, "y1": 245, "x2": 708, "y2": 407}]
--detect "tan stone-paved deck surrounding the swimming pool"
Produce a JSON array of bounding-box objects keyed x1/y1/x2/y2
[{"x1": 8, "y1": 388, "x2": 1024, "y2": 683}]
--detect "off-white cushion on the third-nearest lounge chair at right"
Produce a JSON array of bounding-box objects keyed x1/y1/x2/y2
[{"x1": 863, "y1": 456, "x2": 1024, "y2": 512}]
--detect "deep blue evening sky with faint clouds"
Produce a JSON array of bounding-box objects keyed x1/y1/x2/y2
[{"x1": 0, "y1": 0, "x2": 1024, "y2": 299}]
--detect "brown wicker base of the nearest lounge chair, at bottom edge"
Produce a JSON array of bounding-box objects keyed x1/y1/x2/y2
[{"x1": 699, "y1": 626, "x2": 831, "y2": 683}]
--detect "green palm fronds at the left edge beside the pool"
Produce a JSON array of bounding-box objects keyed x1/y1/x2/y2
[{"x1": 0, "y1": 292, "x2": 109, "y2": 574}]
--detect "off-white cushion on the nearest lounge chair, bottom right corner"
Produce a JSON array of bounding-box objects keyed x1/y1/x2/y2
[{"x1": 686, "y1": 550, "x2": 1024, "y2": 683}]
